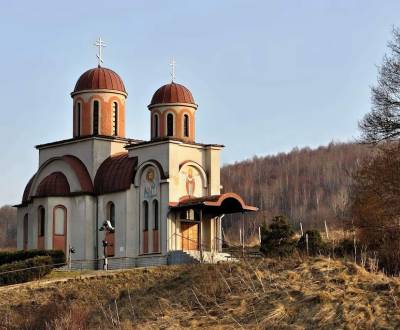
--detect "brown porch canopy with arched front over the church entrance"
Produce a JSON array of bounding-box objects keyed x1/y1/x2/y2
[{"x1": 169, "y1": 193, "x2": 258, "y2": 214}]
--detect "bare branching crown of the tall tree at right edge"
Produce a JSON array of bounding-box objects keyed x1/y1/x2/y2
[{"x1": 359, "y1": 28, "x2": 400, "y2": 143}]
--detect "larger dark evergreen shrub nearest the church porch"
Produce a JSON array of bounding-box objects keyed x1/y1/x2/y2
[{"x1": 260, "y1": 216, "x2": 296, "y2": 257}]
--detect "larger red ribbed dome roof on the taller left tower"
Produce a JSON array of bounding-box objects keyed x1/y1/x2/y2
[{"x1": 71, "y1": 67, "x2": 127, "y2": 95}]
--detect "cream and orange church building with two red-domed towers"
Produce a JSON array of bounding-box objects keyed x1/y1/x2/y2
[{"x1": 17, "y1": 43, "x2": 257, "y2": 267}]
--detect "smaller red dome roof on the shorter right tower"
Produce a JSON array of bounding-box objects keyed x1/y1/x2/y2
[{"x1": 149, "y1": 82, "x2": 196, "y2": 106}]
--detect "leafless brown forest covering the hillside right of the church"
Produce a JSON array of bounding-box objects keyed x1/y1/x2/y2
[{"x1": 221, "y1": 143, "x2": 373, "y2": 240}]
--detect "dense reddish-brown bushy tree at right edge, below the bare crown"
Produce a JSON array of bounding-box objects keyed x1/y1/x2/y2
[{"x1": 350, "y1": 144, "x2": 400, "y2": 274}]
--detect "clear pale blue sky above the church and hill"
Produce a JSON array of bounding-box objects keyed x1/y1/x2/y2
[{"x1": 0, "y1": 0, "x2": 400, "y2": 205}]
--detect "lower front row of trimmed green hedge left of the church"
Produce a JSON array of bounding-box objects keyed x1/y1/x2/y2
[{"x1": 0, "y1": 256, "x2": 53, "y2": 285}]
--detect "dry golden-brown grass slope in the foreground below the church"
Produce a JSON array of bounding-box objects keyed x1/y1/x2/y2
[{"x1": 0, "y1": 258, "x2": 400, "y2": 329}]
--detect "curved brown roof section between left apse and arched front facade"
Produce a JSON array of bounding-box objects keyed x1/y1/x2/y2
[{"x1": 94, "y1": 152, "x2": 138, "y2": 195}]
